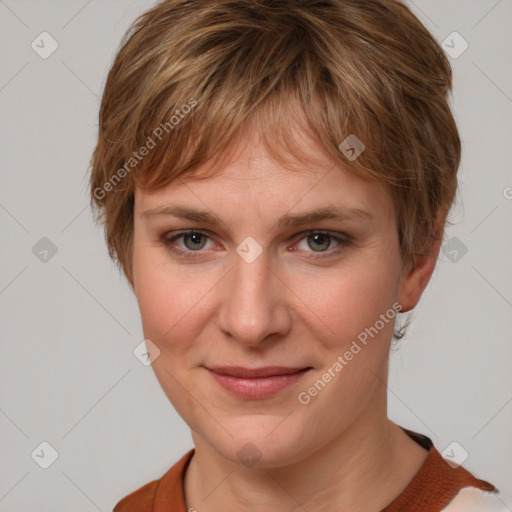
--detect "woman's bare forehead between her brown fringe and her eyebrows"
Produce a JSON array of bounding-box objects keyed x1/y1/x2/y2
[{"x1": 135, "y1": 113, "x2": 393, "y2": 221}]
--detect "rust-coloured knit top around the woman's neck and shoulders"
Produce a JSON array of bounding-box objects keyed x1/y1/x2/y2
[{"x1": 113, "y1": 429, "x2": 505, "y2": 512}]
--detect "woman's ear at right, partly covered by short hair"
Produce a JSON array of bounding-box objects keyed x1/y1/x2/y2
[{"x1": 397, "y1": 223, "x2": 444, "y2": 313}]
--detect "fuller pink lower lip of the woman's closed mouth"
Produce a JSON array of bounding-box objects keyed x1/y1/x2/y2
[{"x1": 209, "y1": 369, "x2": 309, "y2": 398}]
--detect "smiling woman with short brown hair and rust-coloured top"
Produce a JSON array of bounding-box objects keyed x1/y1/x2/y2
[{"x1": 91, "y1": 0, "x2": 500, "y2": 512}]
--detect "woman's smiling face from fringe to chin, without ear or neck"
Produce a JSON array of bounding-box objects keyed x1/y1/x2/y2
[{"x1": 133, "y1": 124, "x2": 426, "y2": 467}]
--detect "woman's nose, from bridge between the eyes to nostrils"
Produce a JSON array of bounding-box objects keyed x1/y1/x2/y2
[{"x1": 219, "y1": 246, "x2": 292, "y2": 346}]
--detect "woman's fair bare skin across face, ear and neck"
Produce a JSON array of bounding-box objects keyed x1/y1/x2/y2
[{"x1": 133, "y1": 121, "x2": 440, "y2": 512}]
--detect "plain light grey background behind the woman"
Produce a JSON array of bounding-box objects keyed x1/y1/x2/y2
[{"x1": 0, "y1": 0, "x2": 512, "y2": 512}]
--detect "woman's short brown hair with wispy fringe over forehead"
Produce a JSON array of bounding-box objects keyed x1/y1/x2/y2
[{"x1": 90, "y1": 0, "x2": 461, "y2": 285}]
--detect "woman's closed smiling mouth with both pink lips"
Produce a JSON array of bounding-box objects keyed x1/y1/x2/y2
[{"x1": 205, "y1": 366, "x2": 312, "y2": 399}]
